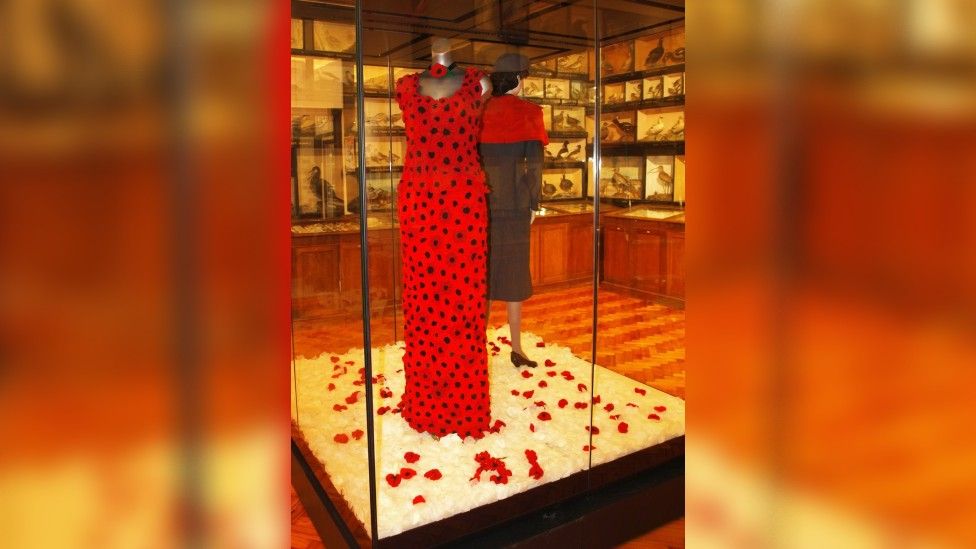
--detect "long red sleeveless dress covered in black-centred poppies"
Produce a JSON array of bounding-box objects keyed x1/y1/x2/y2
[{"x1": 396, "y1": 68, "x2": 491, "y2": 438}]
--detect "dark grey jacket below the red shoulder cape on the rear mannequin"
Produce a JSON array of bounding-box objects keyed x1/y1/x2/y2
[{"x1": 478, "y1": 141, "x2": 543, "y2": 211}]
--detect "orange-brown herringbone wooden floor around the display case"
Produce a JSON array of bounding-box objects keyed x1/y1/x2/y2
[{"x1": 291, "y1": 285, "x2": 685, "y2": 549}]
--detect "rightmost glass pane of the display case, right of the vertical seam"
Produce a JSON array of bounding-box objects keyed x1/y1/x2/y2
[{"x1": 588, "y1": 8, "x2": 685, "y2": 474}]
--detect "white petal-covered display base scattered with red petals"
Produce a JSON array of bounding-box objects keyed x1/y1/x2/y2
[{"x1": 293, "y1": 325, "x2": 685, "y2": 538}]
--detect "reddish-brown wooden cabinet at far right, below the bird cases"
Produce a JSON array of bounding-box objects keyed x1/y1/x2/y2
[{"x1": 601, "y1": 216, "x2": 684, "y2": 299}]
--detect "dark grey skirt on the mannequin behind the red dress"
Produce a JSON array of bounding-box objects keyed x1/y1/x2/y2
[{"x1": 488, "y1": 210, "x2": 532, "y2": 301}]
